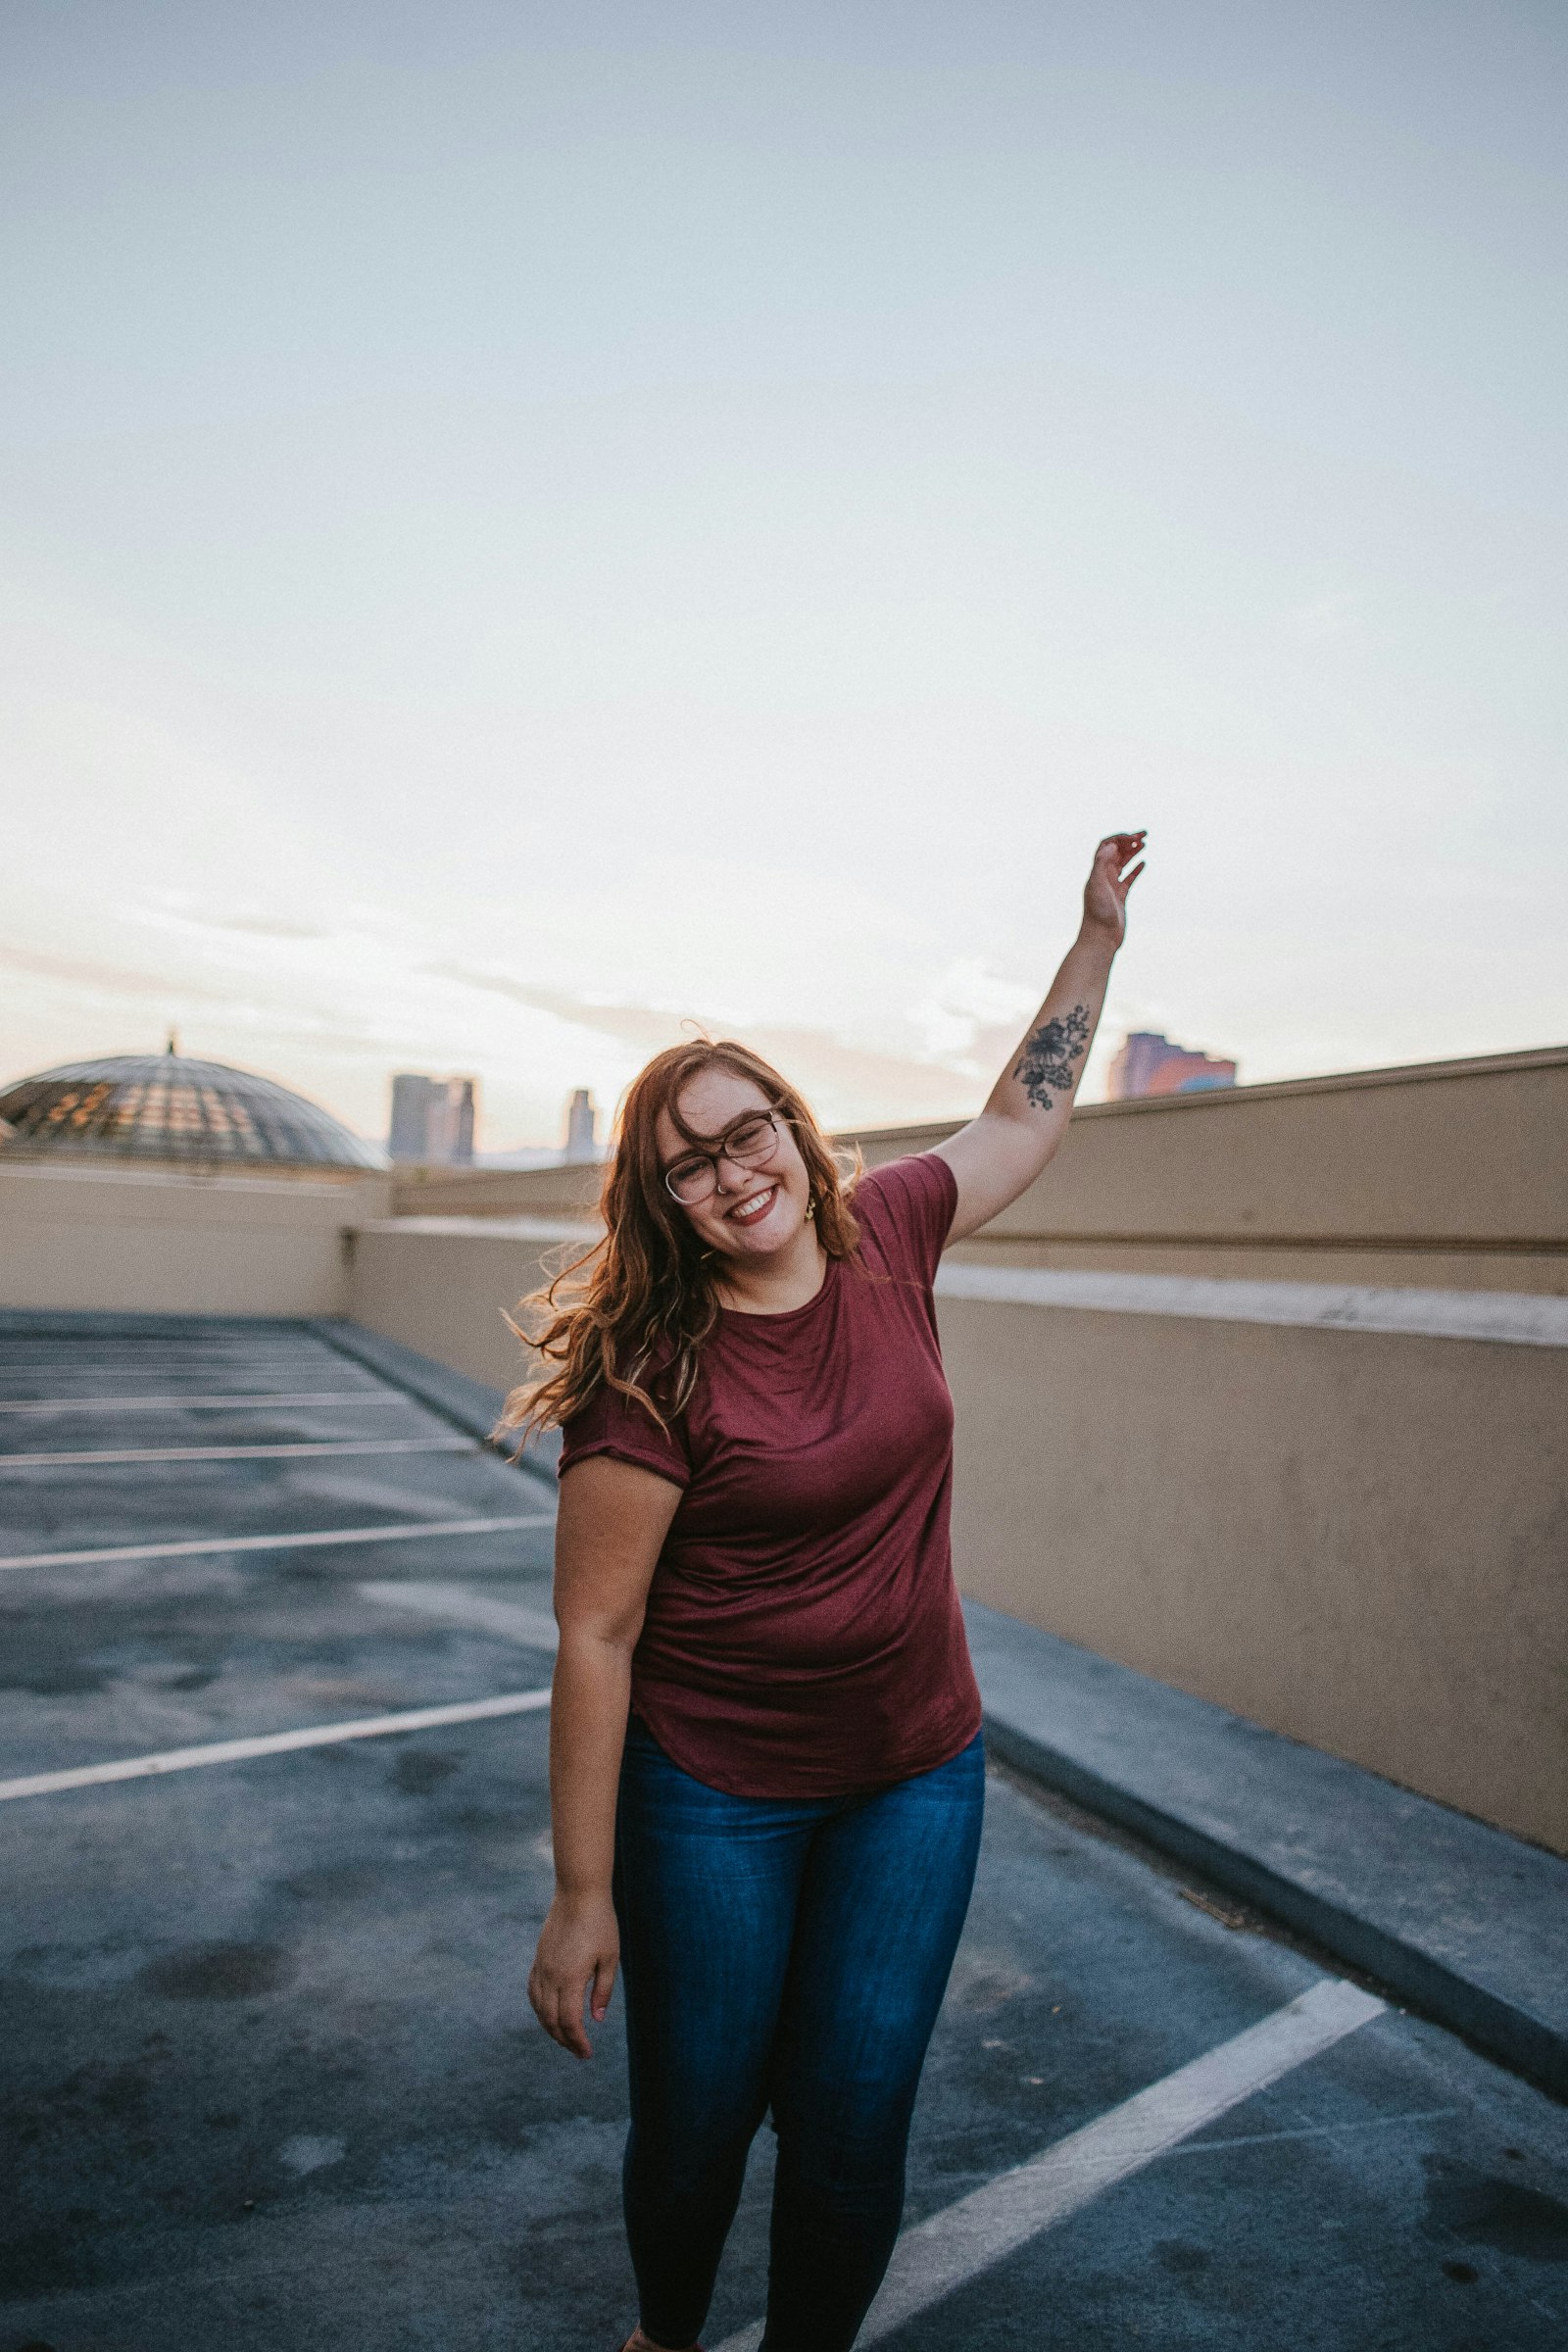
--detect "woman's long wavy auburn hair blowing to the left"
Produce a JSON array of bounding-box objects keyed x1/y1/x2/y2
[{"x1": 496, "y1": 1037, "x2": 862, "y2": 1440}]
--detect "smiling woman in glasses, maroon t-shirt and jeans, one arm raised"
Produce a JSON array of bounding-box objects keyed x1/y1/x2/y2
[{"x1": 506, "y1": 833, "x2": 1143, "y2": 2352}]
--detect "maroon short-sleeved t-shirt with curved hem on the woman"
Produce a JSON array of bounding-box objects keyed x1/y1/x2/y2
[{"x1": 562, "y1": 1152, "x2": 980, "y2": 1797}]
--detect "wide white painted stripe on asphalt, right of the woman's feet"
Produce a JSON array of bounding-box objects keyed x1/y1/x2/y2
[{"x1": 717, "y1": 1978, "x2": 1385, "y2": 2352}]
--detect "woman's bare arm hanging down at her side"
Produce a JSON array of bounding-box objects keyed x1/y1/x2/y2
[{"x1": 529, "y1": 1453, "x2": 679, "y2": 2058}]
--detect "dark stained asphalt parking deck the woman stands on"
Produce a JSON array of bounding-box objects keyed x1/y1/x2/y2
[{"x1": 0, "y1": 1315, "x2": 1568, "y2": 2352}]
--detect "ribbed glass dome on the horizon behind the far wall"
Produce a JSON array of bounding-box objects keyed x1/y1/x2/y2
[{"x1": 0, "y1": 1047, "x2": 385, "y2": 1169}]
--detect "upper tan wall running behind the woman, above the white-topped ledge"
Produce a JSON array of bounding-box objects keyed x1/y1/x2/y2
[{"x1": 395, "y1": 1047, "x2": 1568, "y2": 1296}]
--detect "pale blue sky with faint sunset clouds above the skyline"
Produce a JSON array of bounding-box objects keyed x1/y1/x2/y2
[{"x1": 0, "y1": 0, "x2": 1568, "y2": 1151}]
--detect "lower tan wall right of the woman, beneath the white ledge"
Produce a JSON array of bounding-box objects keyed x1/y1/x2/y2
[{"x1": 941, "y1": 1298, "x2": 1568, "y2": 1851}]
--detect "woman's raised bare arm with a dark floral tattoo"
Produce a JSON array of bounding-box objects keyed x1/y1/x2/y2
[{"x1": 936, "y1": 833, "x2": 1143, "y2": 1242}]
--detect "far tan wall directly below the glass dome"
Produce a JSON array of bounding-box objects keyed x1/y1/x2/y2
[{"x1": 0, "y1": 1162, "x2": 390, "y2": 1315}]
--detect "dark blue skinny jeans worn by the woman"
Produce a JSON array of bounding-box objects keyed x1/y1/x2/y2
[{"x1": 615, "y1": 1719, "x2": 985, "y2": 2352}]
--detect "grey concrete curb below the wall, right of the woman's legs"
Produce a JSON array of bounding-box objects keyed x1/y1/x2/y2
[{"x1": 964, "y1": 1601, "x2": 1568, "y2": 2098}]
